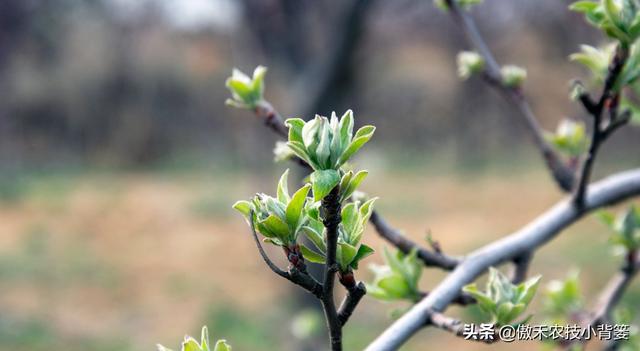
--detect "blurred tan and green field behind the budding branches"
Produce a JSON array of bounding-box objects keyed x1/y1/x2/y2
[{"x1": 0, "y1": 159, "x2": 640, "y2": 351}]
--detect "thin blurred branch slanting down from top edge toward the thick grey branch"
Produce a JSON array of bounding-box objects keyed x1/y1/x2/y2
[{"x1": 446, "y1": 0, "x2": 575, "y2": 192}]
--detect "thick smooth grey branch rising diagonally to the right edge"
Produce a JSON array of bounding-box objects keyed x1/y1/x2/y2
[{"x1": 366, "y1": 169, "x2": 640, "y2": 351}]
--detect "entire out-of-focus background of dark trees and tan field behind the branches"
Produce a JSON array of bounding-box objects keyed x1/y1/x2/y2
[{"x1": 0, "y1": 0, "x2": 640, "y2": 351}]
